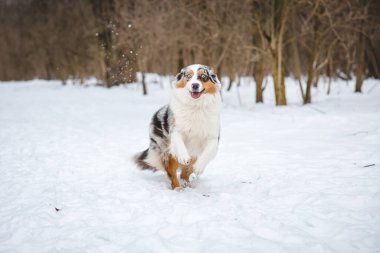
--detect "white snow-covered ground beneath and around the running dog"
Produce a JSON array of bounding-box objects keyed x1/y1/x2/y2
[{"x1": 0, "y1": 77, "x2": 380, "y2": 253}]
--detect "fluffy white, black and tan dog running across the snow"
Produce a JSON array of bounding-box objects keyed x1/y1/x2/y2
[{"x1": 134, "y1": 64, "x2": 221, "y2": 189}]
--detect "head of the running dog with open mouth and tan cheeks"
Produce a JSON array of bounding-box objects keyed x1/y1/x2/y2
[{"x1": 176, "y1": 64, "x2": 221, "y2": 99}]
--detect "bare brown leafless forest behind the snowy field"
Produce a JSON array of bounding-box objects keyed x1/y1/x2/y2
[{"x1": 0, "y1": 0, "x2": 380, "y2": 105}]
